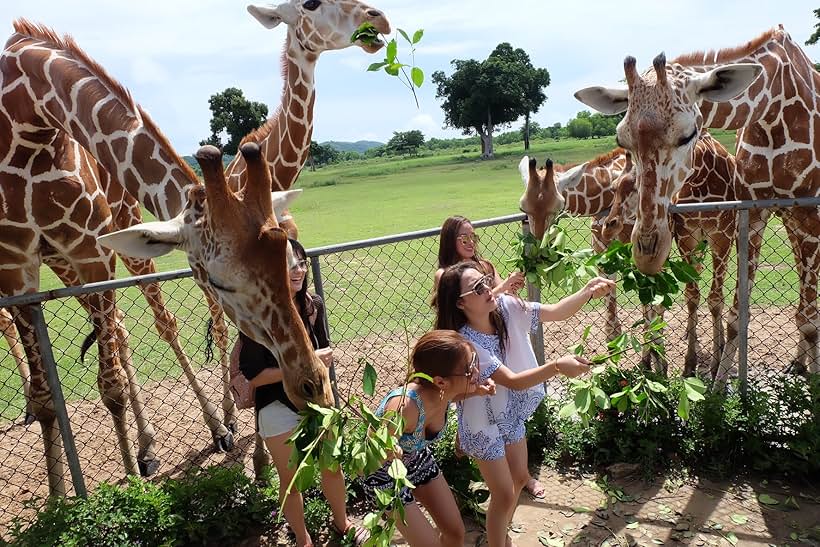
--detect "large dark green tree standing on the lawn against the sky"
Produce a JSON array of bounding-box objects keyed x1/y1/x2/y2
[{"x1": 432, "y1": 42, "x2": 549, "y2": 158}]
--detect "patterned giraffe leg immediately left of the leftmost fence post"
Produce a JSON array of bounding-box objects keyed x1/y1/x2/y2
[{"x1": 12, "y1": 308, "x2": 66, "y2": 496}]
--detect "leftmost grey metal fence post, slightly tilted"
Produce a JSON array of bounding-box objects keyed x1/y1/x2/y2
[{"x1": 29, "y1": 304, "x2": 87, "y2": 497}]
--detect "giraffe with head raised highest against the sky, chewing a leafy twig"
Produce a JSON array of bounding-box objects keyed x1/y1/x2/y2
[{"x1": 226, "y1": 0, "x2": 390, "y2": 239}]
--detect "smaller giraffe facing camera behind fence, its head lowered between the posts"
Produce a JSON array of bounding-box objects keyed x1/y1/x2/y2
[{"x1": 518, "y1": 148, "x2": 627, "y2": 340}]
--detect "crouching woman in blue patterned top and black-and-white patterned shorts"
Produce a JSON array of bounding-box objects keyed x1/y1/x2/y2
[{"x1": 364, "y1": 330, "x2": 495, "y2": 547}]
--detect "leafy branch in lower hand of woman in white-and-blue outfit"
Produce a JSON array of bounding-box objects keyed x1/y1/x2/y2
[{"x1": 558, "y1": 324, "x2": 706, "y2": 426}]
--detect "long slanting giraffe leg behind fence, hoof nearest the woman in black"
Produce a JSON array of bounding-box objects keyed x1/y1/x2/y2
[{"x1": 121, "y1": 257, "x2": 233, "y2": 450}]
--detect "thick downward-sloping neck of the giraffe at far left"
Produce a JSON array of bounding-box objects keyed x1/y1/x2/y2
[{"x1": 0, "y1": 23, "x2": 198, "y2": 220}]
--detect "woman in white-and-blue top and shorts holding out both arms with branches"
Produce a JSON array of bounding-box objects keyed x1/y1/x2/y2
[{"x1": 436, "y1": 262, "x2": 615, "y2": 547}]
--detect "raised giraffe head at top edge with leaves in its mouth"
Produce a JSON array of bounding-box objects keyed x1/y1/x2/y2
[{"x1": 248, "y1": 0, "x2": 390, "y2": 55}]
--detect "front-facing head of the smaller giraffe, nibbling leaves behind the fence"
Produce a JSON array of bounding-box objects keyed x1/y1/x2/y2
[{"x1": 518, "y1": 156, "x2": 564, "y2": 239}]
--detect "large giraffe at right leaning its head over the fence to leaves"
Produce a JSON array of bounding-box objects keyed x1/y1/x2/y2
[{"x1": 575, "y1": 26, "x2": 820, "y2": 385}]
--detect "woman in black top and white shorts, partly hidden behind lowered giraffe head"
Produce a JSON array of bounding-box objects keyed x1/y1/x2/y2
[{"x1": 239, "y1": 239, "x2": 367, "y2": 547}]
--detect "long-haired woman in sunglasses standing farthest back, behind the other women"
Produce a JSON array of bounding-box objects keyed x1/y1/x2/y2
[{"x1": 433, "y1": 215, "x2": 524, "y2": 298}]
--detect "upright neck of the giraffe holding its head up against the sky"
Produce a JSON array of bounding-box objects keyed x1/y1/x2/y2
[{"x1": 227, "y1": 31, "x2": 318, "y2": 191}]
